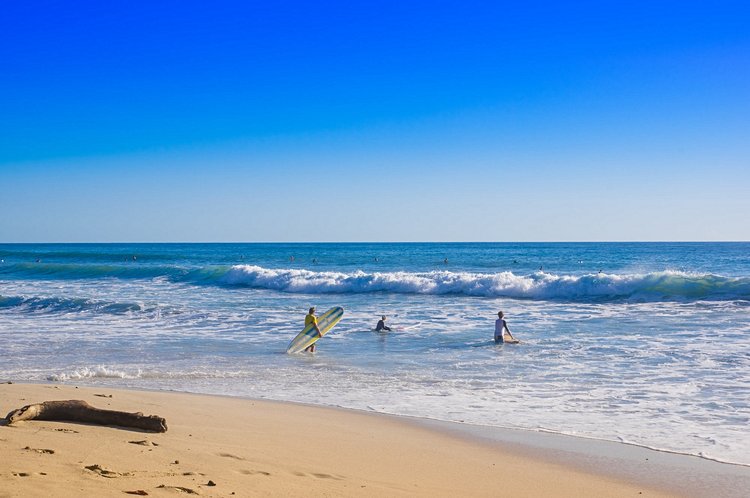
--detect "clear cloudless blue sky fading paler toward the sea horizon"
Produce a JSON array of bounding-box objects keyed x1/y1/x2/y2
[{"x1": 0, "y1": 0, "x2": 750, "y2": 242}]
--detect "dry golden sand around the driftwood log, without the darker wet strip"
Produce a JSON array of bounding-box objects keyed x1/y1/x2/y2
[{"x1": 0, "y1": 384, "x2": 688, "y2": 498}]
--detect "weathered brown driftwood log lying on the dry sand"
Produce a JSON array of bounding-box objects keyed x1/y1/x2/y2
[{"x1": 5, "y1": 400, "x2": 167, "y2": 432}]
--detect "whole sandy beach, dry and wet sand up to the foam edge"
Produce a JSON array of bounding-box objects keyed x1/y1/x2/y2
[{"x1": 0, "y1": 383, "x2": 750, "y2": 497}]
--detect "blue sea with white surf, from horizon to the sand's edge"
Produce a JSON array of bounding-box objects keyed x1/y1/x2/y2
[{"x1": 0, "y1": 243, "x2": 750, "y2": 465}]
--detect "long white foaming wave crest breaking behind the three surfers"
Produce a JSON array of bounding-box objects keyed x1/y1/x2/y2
[{"x1": 221, "y1": 265, "x2": 750, "y2": 301}]
